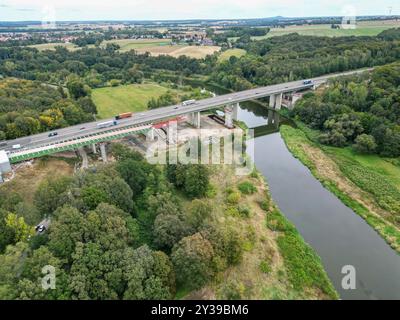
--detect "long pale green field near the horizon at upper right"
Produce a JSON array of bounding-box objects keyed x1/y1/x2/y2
[{"x1": 252, "y1": 20, "x2": 400, "y2": 40}]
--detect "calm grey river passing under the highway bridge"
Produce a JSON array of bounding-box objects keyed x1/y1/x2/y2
[{"x1": 238, "y1": 102, "x2": 400, "y2": 299}]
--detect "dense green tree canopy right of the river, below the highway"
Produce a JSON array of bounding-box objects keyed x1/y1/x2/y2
[{"x1": 292, "y1": 63, "x2": 400, "y2": 157}]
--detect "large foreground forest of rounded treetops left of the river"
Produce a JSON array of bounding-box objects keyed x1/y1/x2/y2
[{"x1": 0, "y1": 144, "x2": 243, "y2": 299}]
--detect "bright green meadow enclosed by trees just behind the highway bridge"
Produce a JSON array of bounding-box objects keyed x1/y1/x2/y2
[{"x1": 92, "y1": 83, "x2": 188, "y2": 119}]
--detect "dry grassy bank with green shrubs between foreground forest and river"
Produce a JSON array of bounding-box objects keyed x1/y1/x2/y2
[{"x1": 184, "y1": 166, "x2": 339, "y2": 300}]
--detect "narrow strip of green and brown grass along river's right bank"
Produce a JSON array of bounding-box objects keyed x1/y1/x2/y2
[{"x1": 281, "y1": 126, "x2": 400, "y2": 252}]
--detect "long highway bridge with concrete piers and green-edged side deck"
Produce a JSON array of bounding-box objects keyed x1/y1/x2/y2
[{"x1": 0, "y1": 69, "x2": 372, "y2": 173}]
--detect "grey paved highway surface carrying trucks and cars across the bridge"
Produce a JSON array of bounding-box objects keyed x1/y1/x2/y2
[{"x1": 0, "y1": 69, "x2": 372, "y2": 152}]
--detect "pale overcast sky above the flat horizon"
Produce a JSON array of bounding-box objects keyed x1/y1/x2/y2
[{"x1": 0, "y1": 0, "x2": 400, "y2": 21}]
